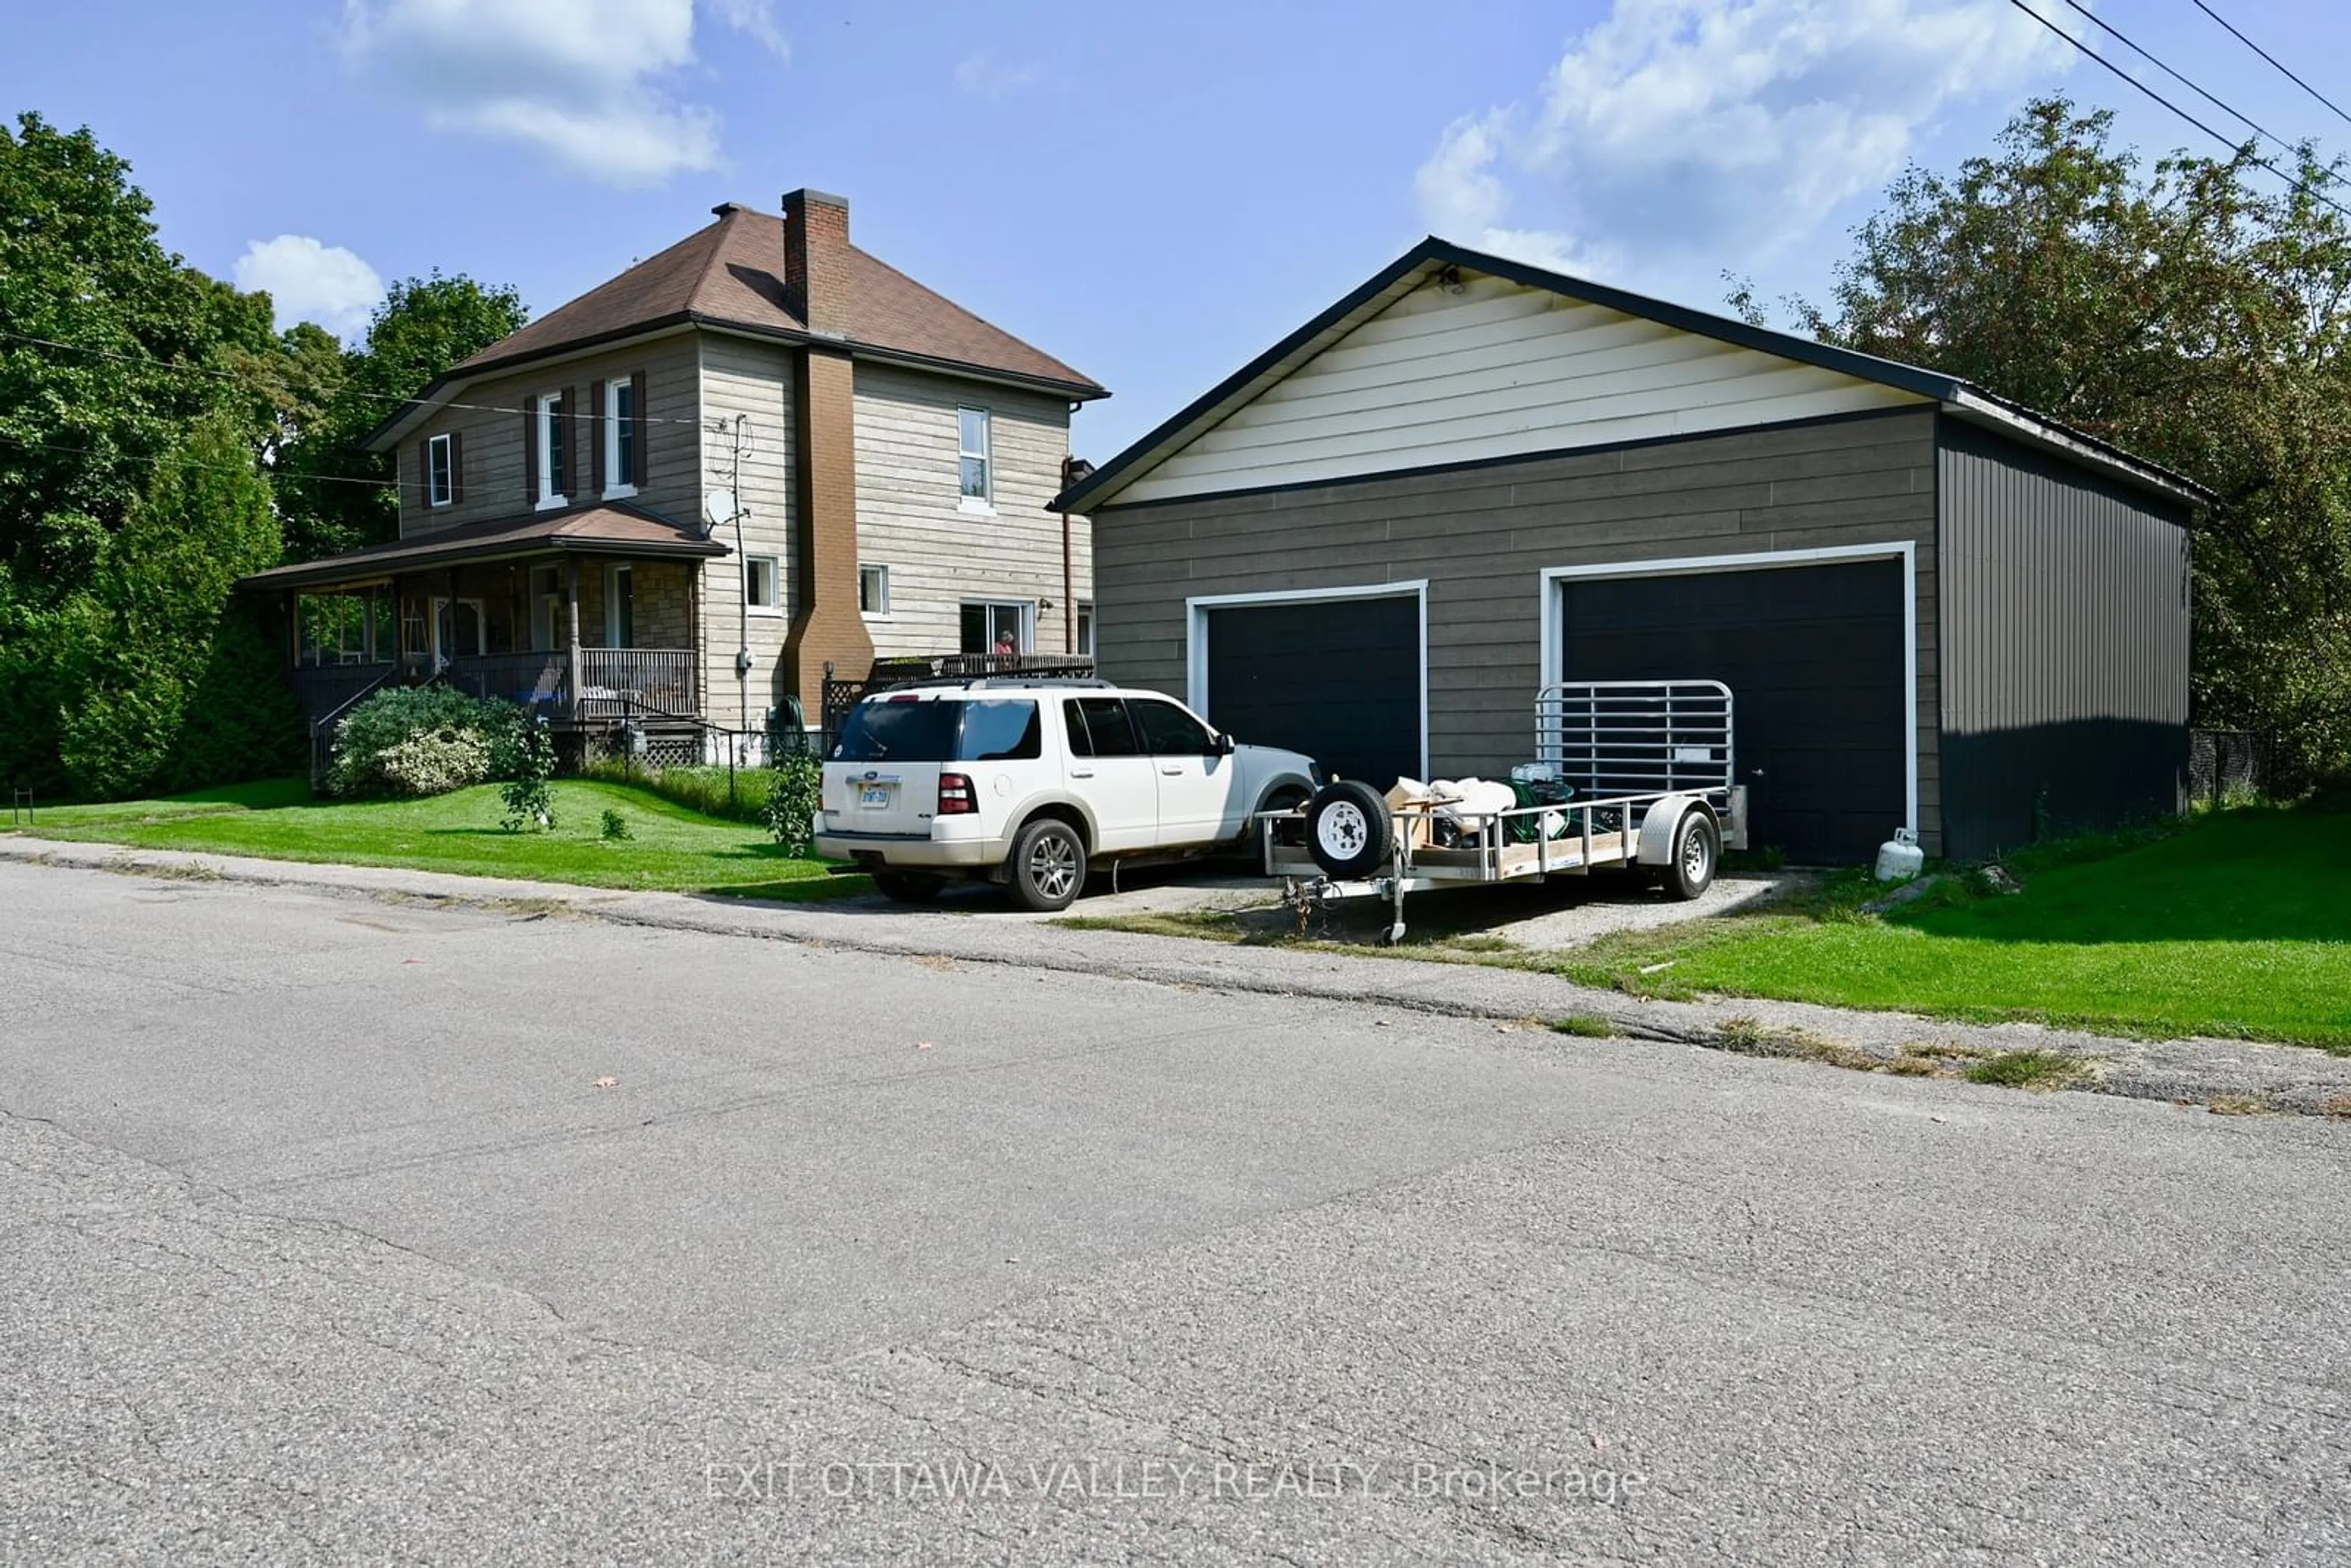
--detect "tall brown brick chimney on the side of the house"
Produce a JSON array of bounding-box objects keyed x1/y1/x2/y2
[{"x1": 778, "y1": 190, "x2": 874, "y2": 712}]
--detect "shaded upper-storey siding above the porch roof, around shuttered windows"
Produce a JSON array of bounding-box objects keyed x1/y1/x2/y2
[{"x1": 400, "y1": 331, "x2": 700, "y2": 538}]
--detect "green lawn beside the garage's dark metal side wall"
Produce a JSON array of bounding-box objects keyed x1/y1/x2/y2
[{"x1": 1067, "y1": 799, "x2": 2351, "y2": 1056}]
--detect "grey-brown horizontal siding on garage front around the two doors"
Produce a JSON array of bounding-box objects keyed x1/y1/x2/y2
[{"x1": 1093, "y1": 409, "x2": 1942, "y2": 849}]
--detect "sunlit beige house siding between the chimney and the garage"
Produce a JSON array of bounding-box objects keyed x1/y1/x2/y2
[{"x1": 856, "y1": 362, "x2": 1093, "y2": 658}]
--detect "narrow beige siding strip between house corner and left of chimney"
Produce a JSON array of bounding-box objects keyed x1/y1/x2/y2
[{"x1": 698, "y1": 331, "x2": 804, "y2": 729}]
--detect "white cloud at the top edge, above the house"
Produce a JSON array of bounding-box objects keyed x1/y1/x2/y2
[{"x1": 343, "y1": 0, "x2": 743, "y2": 186}]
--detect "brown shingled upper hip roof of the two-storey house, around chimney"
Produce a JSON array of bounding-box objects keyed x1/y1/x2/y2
[{"x1": 451, "y1": 204, "x2": 1105, "y2": 397}]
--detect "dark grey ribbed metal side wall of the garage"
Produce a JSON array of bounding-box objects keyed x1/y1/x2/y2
[{"x1": 1937, "y1": 416, "x2": 2189, "y2": 858}]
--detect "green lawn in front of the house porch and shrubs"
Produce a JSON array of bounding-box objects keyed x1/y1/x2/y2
[{"x1": 13, "y1": 778, "x2": 868, "y2": 901}]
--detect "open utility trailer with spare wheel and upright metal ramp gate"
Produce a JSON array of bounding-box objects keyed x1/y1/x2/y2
[{"x1": 1258, "y1": 680, "x2": 1747, "y2": 943}]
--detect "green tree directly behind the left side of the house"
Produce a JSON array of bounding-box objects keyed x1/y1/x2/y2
[{"x1": 277, "y1": 272, "x2": 529, "y2": 560}]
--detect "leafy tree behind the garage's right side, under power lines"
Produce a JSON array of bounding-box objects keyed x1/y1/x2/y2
[{"x1": 1768, "y1": 99, "x2": 2351, "y2": 778}]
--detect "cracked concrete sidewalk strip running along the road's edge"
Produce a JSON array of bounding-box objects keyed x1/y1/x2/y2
[{"x1": 0, "y1": 837, "x2": 2351, "y2": 1117}]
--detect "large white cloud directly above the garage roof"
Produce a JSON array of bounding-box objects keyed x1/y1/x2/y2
[{"x1": 1413, "y1": 0, "x2": 2071, "y2": 285}]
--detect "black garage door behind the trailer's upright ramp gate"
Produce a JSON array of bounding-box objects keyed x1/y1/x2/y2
[{"x1": 1561, "y1": 560, "x2": 1911, "y2": 863}]
